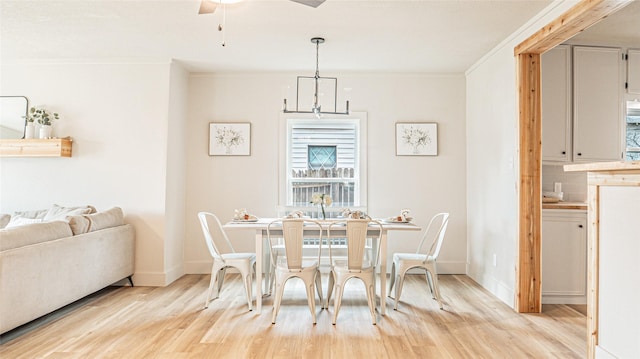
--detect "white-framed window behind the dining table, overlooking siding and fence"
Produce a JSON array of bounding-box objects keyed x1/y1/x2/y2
[{"x1": 280, "y1": 114, "x2": 367, "y2": 218}]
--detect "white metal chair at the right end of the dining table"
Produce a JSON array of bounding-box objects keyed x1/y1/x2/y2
[{"x1": 389, "y1": 213, "x2": 449, "y2": 310}]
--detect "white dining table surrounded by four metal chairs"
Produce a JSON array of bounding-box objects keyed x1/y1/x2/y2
[{"x1": 223, "y1": 218, "x2": 422, "y2": 315}]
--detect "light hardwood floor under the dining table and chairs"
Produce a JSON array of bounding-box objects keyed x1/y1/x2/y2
[{"x1": 0, "y1": 274, "x2": 587, "y2": 359}]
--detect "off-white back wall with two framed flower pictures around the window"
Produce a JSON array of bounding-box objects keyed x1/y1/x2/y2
[{"x1": 185, "y1": 73, "x2": 466, "y2": 273}]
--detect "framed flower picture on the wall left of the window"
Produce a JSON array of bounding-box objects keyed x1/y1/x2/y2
[{"x1": 209, "y1": 122, "x2": 251, "y2": 156}]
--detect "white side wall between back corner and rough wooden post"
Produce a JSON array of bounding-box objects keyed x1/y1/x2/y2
[{"x1": 466, "y1": 1, "x2": 575, "y2": 306}]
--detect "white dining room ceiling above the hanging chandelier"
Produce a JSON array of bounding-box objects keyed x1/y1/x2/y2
[{"x1": 0, "y1": 0, "x2": 637, "y2": 73}]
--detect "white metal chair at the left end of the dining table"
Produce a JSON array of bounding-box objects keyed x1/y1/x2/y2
[{"x1": 198, "y1": 212, "x2": 256, "y2": 310}]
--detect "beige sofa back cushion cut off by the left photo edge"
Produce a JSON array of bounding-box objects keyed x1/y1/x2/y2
[{"x1": 0, "y1": 221, "x2": 73, "y2": 251}]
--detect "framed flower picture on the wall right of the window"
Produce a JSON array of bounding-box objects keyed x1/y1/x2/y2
[{"x1": 396, "y1": 122, "x2": 438, "y2": 156}]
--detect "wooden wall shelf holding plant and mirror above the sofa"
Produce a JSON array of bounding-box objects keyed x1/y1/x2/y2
[{"x1": 0, "y1": 137, "x2": 72, "y2": 157}]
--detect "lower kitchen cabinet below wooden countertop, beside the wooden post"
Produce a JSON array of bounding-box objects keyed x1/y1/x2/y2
[{"x1": 541, "y1": 209, "x2": 587, "y2": 304}]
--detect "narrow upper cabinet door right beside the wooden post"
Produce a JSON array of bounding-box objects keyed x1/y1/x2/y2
[{"x1": 540, "y1": 45, "x2": 571, "y2": 162}]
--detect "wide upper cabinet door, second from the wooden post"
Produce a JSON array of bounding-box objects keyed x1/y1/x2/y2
[{"x1": 573, "y1": 46, "x2": 623, "y2": 162}]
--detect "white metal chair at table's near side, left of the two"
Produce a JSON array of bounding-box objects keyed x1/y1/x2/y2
[{"x1": 267, "y1": 218, "x2": 324, "y2": 324}]
